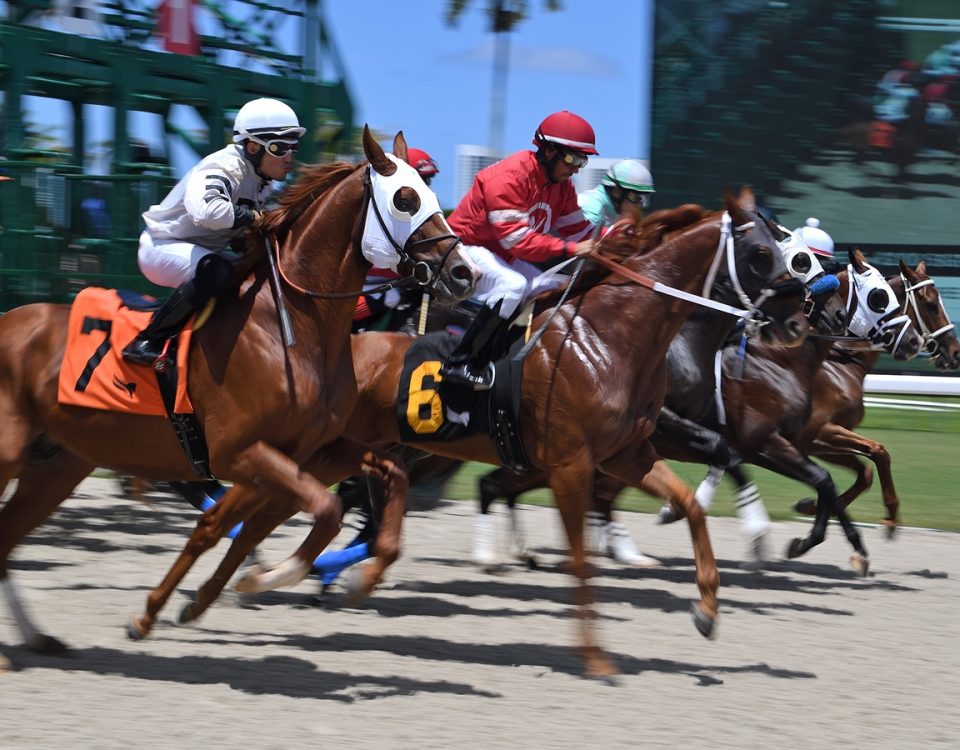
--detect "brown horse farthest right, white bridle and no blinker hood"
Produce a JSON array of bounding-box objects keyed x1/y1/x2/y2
[{"x1": 795, "y1": 260, "x2": 960, "y2": 534}]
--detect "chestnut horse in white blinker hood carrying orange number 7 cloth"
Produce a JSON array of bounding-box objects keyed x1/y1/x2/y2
[{"x1": 0, "y1": 129, "x2": 475, "y2": 652}]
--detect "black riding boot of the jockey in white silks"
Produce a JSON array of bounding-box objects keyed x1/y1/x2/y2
[{"x1": 123, "y1": 253, "x2": 233, "y2": 370}]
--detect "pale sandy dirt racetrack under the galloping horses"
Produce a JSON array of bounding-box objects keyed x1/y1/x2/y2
[{"x1": 0, "y1": 479, "x2": 960, "y2": 750}]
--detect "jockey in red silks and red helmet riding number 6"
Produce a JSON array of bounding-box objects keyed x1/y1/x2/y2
[{"x1": 440, "y1": 110, "x2": 597, "y2": 390}]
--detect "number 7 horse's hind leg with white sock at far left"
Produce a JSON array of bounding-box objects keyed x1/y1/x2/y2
[{"x1": 0, "y1": 450, "x2": 94, "y2": 654}]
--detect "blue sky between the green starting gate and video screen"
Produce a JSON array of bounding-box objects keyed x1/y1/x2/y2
[{"x1": 324, "y1": 0, "x2": 653, "y2": 205}]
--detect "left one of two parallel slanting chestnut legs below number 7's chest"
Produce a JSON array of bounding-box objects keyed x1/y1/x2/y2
[{"x1": 127, "y1": 484, "x2": 266, "y2": 640}]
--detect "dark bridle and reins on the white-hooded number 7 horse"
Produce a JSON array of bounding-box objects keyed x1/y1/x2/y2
[{"x1": 264, "y1": 165, "x2": 460, "y2": 299}]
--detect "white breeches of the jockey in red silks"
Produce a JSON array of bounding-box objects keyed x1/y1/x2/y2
[{"x1": 461, "y1": 245, "x2": 567, "y2": 320}]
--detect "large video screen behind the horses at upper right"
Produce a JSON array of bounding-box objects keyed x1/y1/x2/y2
[{"x1": 651, "y1": 0, "x2": 960, "y2": 247}]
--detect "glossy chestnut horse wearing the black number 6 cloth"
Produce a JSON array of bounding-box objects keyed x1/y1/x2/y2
[{"x1": 135, "y1": 189, "x2": 806, "y2": 675}]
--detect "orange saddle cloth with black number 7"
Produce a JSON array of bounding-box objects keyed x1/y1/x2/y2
[{"x1": 57, "y1": 287, "x2": 193, "y2": 416}]
